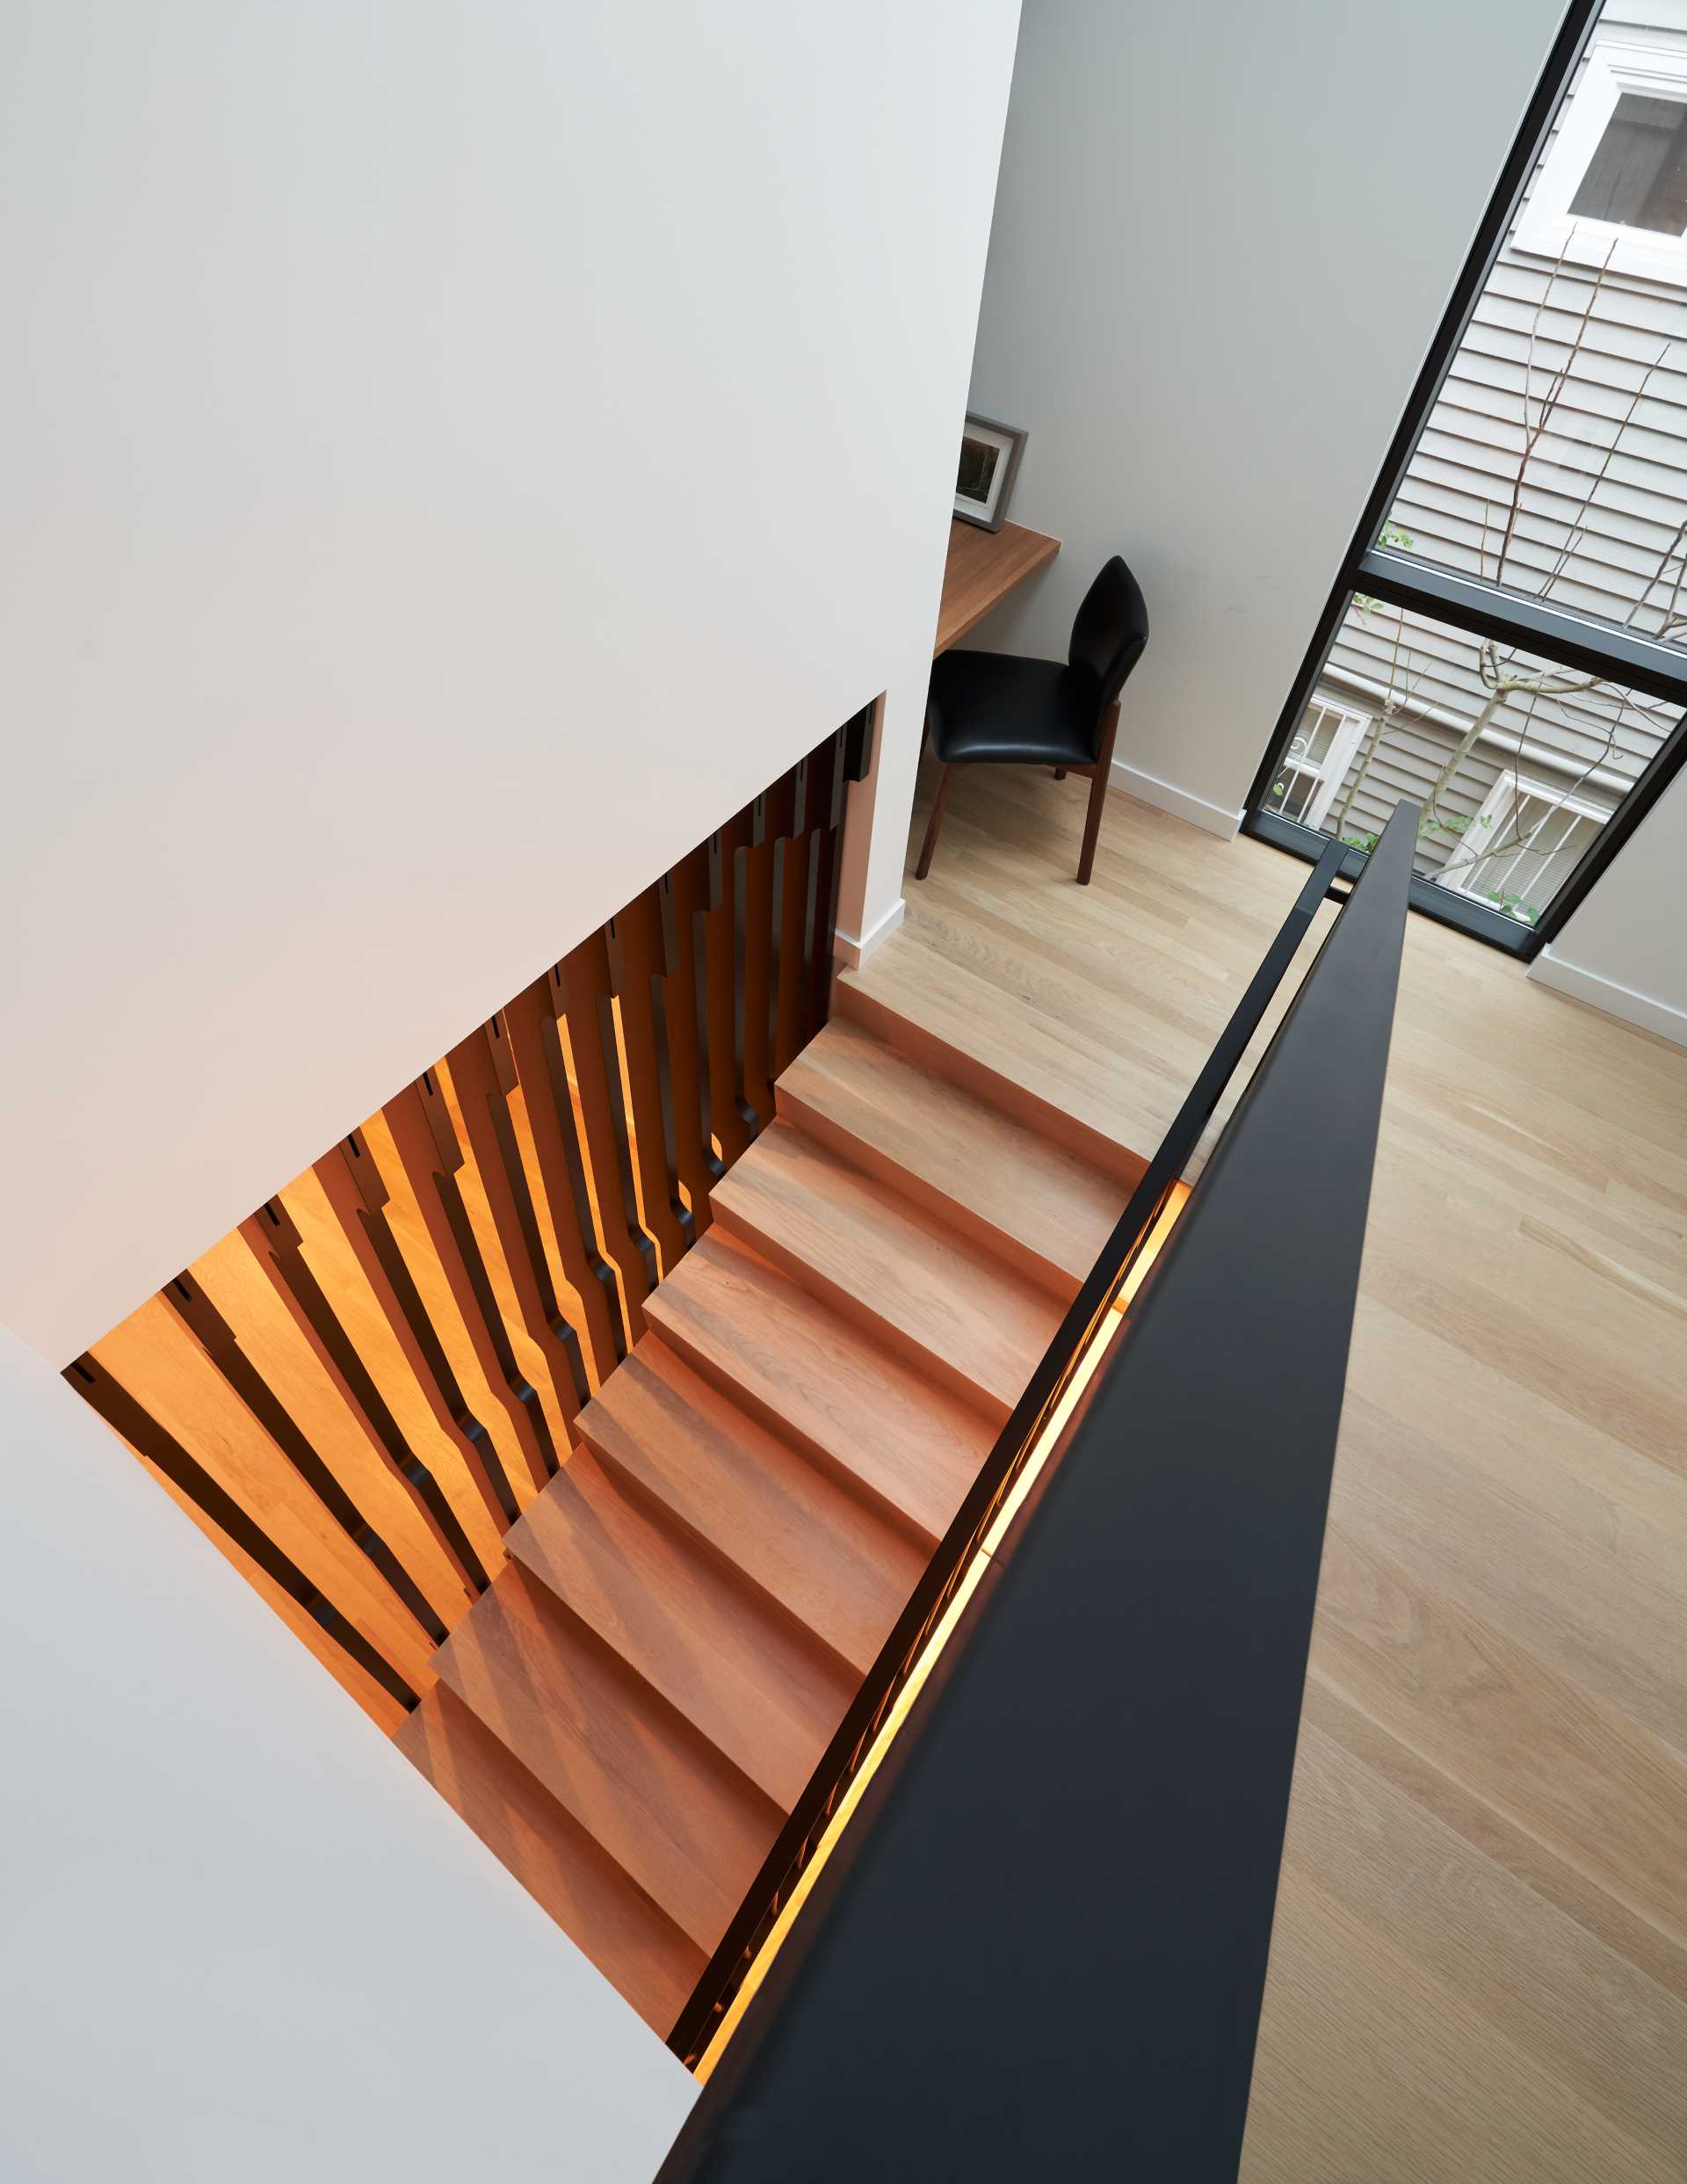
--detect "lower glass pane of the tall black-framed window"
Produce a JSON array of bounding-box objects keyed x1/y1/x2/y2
[{"x1": 1263, "y1": 599, "x2": 1678, "y2": 926}]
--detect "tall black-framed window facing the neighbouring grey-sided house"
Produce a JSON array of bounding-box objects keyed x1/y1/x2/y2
[{"x1": 1246, "y1": 0, "x2": 1687, "y2": 956}]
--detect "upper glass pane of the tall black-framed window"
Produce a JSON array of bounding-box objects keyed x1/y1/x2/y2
[{"x1": 1381, "y1": 0, "x2": 1687, "y2": 651}]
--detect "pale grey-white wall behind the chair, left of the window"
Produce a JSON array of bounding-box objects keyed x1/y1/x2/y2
[{"x1": 955, "y1": 0, "x2": 1562, "y2": 832}]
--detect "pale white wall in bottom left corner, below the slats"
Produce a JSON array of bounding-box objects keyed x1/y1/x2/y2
[{"x1": 0, "y1": 1332, "x2": 696, "y2": 2184}]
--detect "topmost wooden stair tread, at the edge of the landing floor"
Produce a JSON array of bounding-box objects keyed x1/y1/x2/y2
[{"x1": 836, "y1": 935, "x2": 1152, "y2": 1186}]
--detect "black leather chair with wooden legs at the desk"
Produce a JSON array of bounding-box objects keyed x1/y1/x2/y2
[{"x1": 915, "y1": 555, "x2": 1148, "y2": 887}]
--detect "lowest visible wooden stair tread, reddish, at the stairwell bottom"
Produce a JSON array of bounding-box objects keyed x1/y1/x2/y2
[{"x1": 393, "y1": 1684, "x2": 707, "y2": 2040}]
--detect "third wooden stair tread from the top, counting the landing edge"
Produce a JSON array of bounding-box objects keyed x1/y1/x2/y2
[{"x1": 713, "y1": 1121, "x2": 1061, "y2": 1422}]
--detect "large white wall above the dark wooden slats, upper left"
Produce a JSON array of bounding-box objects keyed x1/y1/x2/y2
[{"x1": 0, "y1": 0, "x2": 1017, "y2": 1360}]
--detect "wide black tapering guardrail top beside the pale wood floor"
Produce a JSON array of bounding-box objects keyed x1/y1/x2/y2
[{"x1": 662, "y1": 806, "x2": 1416, "y2": 2184}]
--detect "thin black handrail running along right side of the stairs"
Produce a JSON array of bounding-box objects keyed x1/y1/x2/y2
[{"x1": 668, "y1": 806, "x2": 1379, "y2": 2064}]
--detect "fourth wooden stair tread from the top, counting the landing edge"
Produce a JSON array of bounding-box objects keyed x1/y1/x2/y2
[{"x1": 646, "y1": 1230, "x2": 996, "y2": 1550}]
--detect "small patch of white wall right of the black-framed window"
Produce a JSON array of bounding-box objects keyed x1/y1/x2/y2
[{"x1": 1530, "y1": 773, "x2": 1687, "y2": 1046}]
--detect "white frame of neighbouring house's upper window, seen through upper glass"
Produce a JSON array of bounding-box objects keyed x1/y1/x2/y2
[{"x1": 1512, "y1": 40, "x2": 1687, "y2": 287}]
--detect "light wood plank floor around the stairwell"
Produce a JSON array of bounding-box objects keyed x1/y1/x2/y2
[{"x1": 903, "y1": 769, "x2": 1687, "y2": 2184}]
